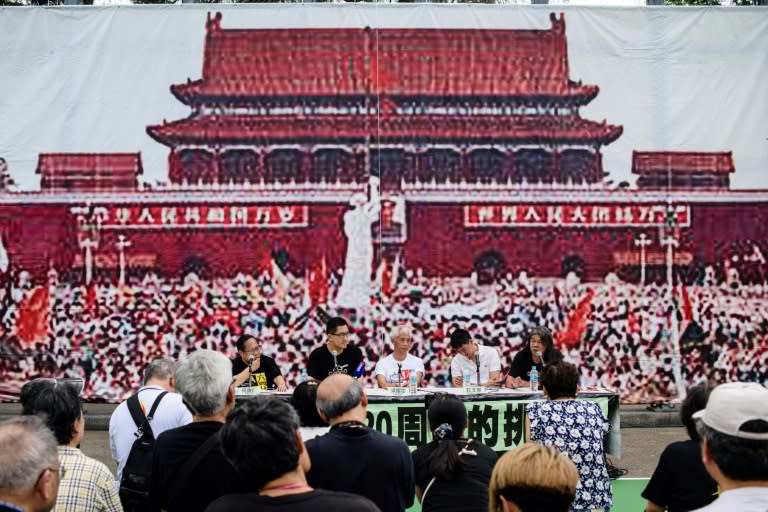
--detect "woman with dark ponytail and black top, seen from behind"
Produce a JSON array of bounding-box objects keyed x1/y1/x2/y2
[{"x1": 413, "y1": 394, "x2": 497, "y2": 512}]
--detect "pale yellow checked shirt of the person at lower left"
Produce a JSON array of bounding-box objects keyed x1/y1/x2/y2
[{"x1": 53, "y1": 446, "x2": 123, "y2": 512}]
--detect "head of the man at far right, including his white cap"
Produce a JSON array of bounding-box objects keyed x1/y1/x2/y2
[{"x1": 693, "y1": 382, "x2": 768, "y2": 489}]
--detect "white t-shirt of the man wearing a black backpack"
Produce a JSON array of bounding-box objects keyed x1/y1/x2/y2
[{"x1": 109, "y1": 386, "x2": 192, "y2": 486}]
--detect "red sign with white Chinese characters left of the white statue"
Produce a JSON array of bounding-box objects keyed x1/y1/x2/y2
[{"x1": 73, "y1": 204, "x2": 309, "y2": 229}]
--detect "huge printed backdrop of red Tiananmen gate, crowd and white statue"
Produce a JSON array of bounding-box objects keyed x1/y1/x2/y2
[{"x1": 0, "y1": 4, "x2": 768, "y2": 404}]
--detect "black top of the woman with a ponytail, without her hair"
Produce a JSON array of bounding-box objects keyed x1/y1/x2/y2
[{"x1": 413, "y1": 441, "x2": 498, "y2": 512}]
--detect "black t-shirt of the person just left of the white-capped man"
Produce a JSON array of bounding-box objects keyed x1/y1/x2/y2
[{"x1": 641, "y1": 440, "x2": 717, "y2": 512}]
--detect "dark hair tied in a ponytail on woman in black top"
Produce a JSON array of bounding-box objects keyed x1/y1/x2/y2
[{"x1": 427, "y1": 393, "x2": 467, "y2": 480}]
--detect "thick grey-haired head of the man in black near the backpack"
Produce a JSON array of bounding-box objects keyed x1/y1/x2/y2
[{"x1": 176, "y1": 350, "x2": 234, "y2": 417}]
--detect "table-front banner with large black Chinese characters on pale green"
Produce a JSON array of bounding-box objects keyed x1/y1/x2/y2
[{"x1": 368, "y1": 397, "x2": 610, "y2": 452}]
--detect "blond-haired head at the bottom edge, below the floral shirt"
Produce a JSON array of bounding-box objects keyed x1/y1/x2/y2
[{"x1": 488, "y1": 443, "x2": 579, "y2": 512}]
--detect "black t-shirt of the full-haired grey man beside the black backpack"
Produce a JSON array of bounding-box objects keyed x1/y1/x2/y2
[{"x1": 150, "y1": 421, "x2": 248, "y2": 512}]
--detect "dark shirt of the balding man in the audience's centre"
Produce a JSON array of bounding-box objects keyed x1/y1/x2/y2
[{"x1": 306, "y1": 427, "x2": 415, "y2": 512}]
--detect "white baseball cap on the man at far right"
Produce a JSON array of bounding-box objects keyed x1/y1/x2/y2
[{"x1": 693, "y1": 382, "x2": 768, "y2": 441}]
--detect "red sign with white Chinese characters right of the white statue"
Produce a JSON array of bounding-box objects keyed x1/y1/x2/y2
[{"x1": 464, "y1": 203, "x2": 691, "y2": 228}]
